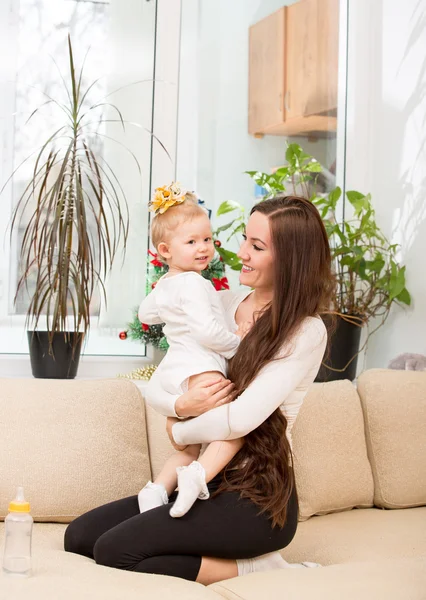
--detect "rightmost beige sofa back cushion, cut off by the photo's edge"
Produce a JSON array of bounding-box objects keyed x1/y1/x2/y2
[{"x1": 358, "y1": 369, "x2": 426, "y2": 508}]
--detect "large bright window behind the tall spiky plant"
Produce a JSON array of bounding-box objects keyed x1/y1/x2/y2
[{"x1": 0, "y1": 0, "x2": 157, "y2": 355}]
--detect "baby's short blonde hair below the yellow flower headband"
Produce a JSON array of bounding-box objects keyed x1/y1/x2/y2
[{"x1": 151, "y1": 192, "x2": 207, "y2": 262}]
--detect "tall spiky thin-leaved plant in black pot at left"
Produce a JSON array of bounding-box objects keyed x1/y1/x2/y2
[{"x1": 3, "y1": 36, "x2": 135, "y2": 378}]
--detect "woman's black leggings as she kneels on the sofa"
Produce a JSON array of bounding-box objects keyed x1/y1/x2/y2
[{"x1": 64, "y1": 475, "x2": 298, "y2": 581}]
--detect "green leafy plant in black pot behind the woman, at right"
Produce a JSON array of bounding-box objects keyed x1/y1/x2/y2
[{"x1": 312, "y1": 188, "x2": 411, "y2": 381}]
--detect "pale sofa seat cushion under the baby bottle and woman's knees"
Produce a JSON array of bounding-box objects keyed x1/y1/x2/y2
[{"x1": 0, "y1": 523, "x2": 218, "y2": 600}]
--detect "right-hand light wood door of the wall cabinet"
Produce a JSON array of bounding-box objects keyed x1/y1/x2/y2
[{"x1": 284, "y1": 0, "x2": 339, "y2": 120}]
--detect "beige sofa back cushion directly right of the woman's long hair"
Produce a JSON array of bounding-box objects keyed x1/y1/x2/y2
[{"x1": 292, "y1": 381, "x2": 374, "y2": 520}]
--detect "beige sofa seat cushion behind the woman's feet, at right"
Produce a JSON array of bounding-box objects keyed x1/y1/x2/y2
[{"x1": 281, "y1": 507, "x2": 426, "y2": 568}]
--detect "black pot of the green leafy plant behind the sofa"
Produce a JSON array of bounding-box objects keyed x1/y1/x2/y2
[{"x1": 315, "y1": 316, "x2": 362, "y2": 382}]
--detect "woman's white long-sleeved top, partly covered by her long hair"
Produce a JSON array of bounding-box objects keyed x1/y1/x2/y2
[{"x1": 146, "y1": 291, "x2": 327, "y2": 445}]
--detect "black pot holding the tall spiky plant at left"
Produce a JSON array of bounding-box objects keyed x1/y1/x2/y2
[{"x1": 27, "y1": 331, "x2": 84, "y2": 379}]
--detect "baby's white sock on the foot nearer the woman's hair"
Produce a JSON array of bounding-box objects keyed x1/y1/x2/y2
[{"x1": 170, "y1": 460, "x2": 210, "y2": 517}]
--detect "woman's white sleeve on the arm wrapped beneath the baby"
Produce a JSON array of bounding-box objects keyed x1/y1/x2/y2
[{"x1": 173, "y1": 319, "x2": 327, "y2": 445}]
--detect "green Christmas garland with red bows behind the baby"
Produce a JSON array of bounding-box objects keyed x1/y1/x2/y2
[{"x1": 120, "y1": 245, "x2": 229, "y2": 352}]
